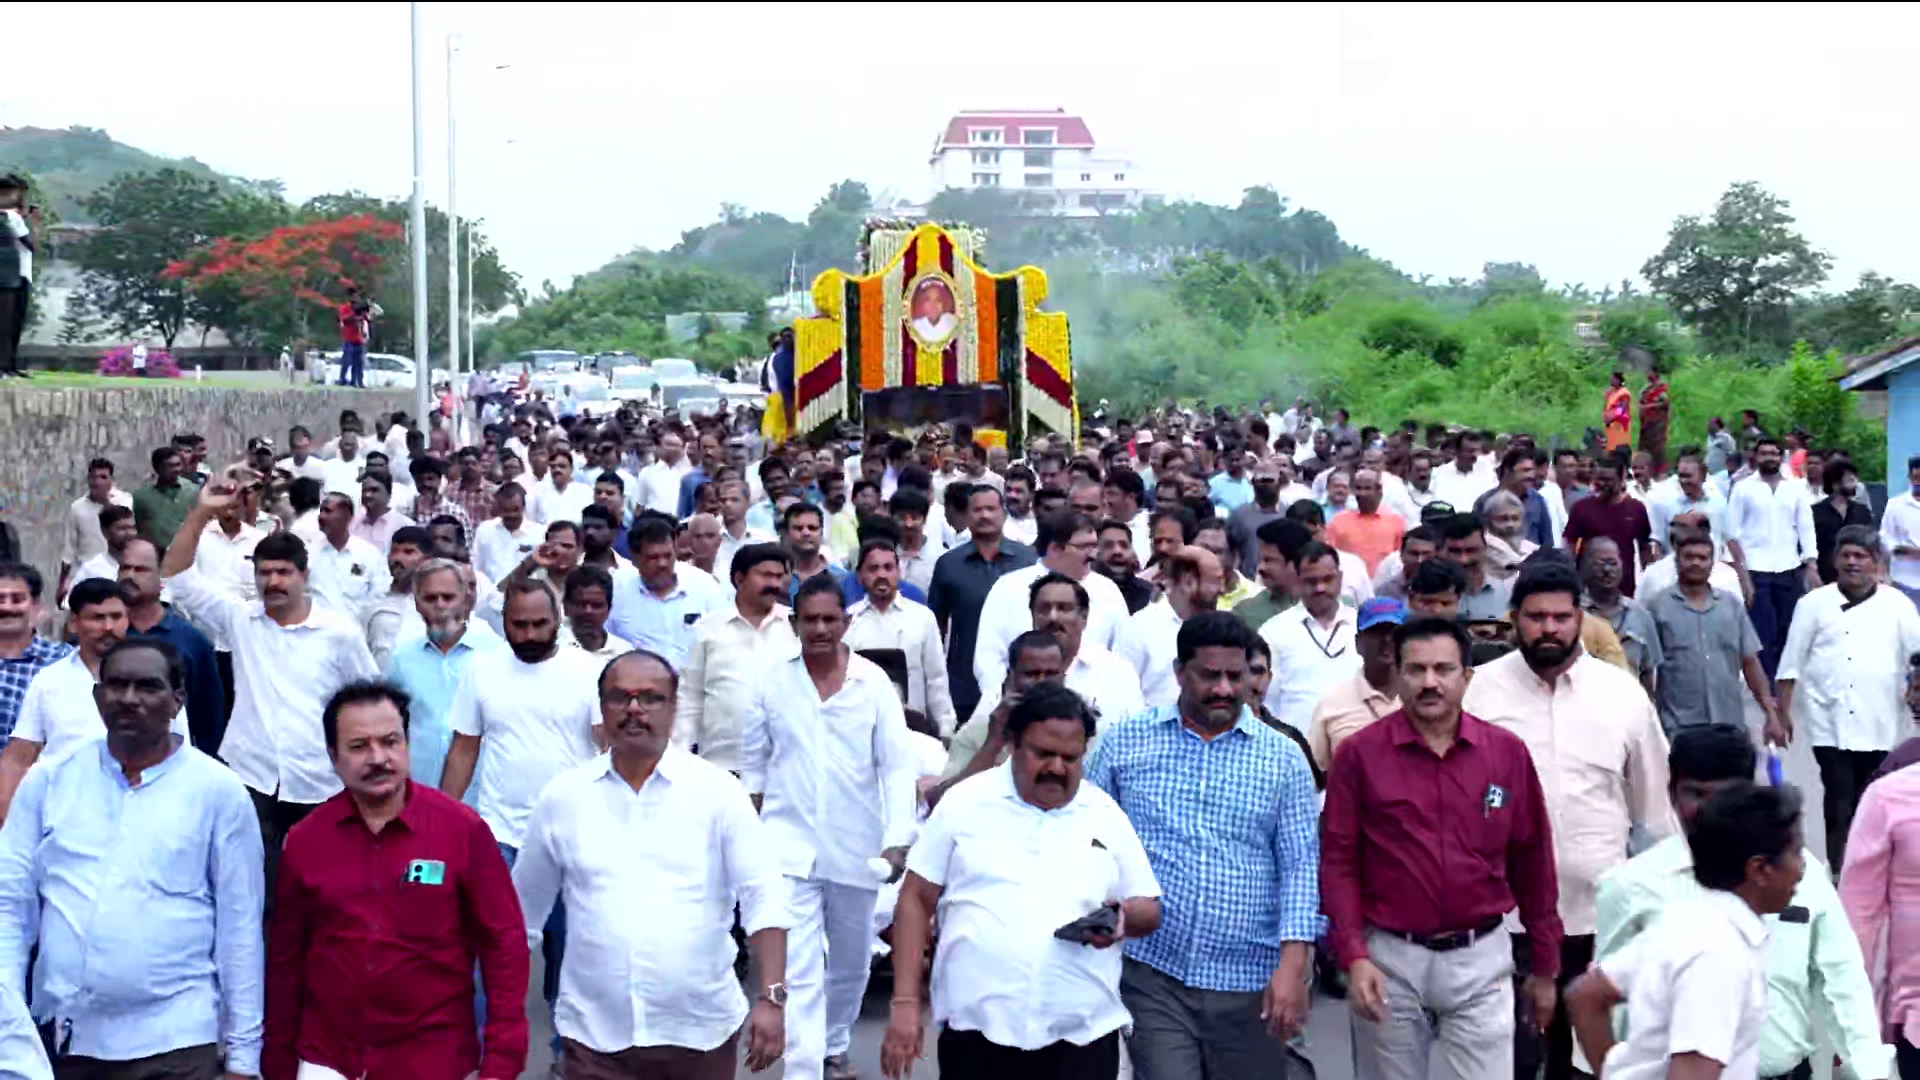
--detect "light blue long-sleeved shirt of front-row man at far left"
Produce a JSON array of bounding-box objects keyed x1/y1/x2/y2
[{"x1": 0, "y1": 740, "x2": 265, "y2": 1074}]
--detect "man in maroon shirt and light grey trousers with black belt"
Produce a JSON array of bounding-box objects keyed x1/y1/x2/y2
[{"x1": 1321, "y1": 619, "x2": 1563, "y2": 1080}]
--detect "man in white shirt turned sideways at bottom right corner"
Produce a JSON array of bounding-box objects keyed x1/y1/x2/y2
[{"x1": 1567, "y1": 782, "x2": 1805, "y2": 1080}]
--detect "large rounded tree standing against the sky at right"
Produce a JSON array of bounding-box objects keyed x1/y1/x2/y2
[{"x1": 1640, "y1": 181, "x2": 1832, "y2": 350}]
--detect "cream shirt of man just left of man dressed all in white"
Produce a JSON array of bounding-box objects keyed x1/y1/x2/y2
[{"x1": 674, "y1": 601, "x2": 801, "y2": 773}]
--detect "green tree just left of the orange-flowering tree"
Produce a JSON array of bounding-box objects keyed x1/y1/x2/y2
[{"x1": 79, "y1": 169, "x2": 228, "y2": 350}]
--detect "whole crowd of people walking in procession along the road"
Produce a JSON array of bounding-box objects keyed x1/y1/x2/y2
[{"x1": 0, "y1": 386, "x2": 1920, "y2": 1080}]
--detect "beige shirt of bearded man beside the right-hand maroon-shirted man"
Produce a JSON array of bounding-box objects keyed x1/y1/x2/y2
[{"x1": 1461, "y1": 651, "x2": 1680, "y2": 936}]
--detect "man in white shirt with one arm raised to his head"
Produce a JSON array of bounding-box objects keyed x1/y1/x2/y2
[{"x1": 159, "y1": 479, "x2": 378, "y2": 896}]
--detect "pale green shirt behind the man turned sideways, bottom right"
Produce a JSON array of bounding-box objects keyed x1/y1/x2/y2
[{"x1": 1594, "y1": 836, "x2": 1891, "y2": 1080}]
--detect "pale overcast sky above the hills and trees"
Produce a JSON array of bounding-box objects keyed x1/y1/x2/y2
[{"x1": 0, "y1": 4, "x2": 1920, "y2": 286}]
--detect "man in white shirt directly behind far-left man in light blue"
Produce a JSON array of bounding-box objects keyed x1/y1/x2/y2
[{"x1": 0, "y1": 578, "x2": 186, "y2": 819}]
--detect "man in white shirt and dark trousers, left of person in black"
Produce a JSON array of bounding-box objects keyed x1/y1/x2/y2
[{"x1": 1726, "y1": 434, "x2": 1832, "y2": 672}]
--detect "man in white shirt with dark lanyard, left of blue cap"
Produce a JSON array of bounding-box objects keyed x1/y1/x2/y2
[{"x1": 1260, "y1": 540, "x2": 1359, "y2": 734}]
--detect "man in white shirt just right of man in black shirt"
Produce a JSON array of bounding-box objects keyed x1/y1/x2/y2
[{"x1": 973, "y1": 509, "x2": 1131, "y2": 692}]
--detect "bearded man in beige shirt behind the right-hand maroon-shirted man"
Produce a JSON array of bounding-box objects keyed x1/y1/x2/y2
[{"x1": 1461, "y1": 561, "x2": 1678, "y2": 1080}]
